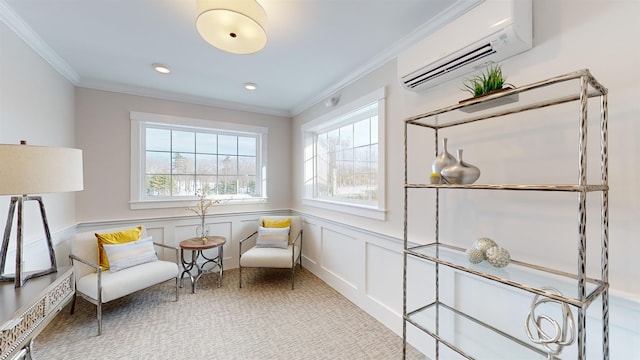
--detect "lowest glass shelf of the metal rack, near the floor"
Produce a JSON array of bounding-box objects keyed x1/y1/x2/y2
[{"x1": 407, "y1": 302, "x2": 558, "y2": 360}]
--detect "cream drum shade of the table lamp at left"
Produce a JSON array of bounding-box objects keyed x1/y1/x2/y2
[{"x1": 0, "y1": 144, "x2": 84, "y2": 195}]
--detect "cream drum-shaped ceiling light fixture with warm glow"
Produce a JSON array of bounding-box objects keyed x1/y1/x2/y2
[{"x1": 196, "y1": 0, "x2": 267, "y2": 54}]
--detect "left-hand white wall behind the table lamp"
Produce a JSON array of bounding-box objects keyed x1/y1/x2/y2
[{"x1": 0, "y1": 22, "x2": 76, "y2": 273}]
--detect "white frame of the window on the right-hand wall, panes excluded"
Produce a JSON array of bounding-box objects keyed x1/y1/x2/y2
[{"x1": 301, "y1": 87, "x2": 387, "y2": 220}]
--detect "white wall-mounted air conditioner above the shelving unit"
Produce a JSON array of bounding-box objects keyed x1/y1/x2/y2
[{"x1": 398, "y1": 0, "x2": 533, "y2": 91}]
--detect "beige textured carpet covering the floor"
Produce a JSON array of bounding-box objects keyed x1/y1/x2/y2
[{"x1": 33, "y1": 269, "x2": 424, "y2": 360}]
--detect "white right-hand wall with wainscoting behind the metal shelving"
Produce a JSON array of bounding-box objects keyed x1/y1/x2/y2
[{"x1": 292, "y1": 0, "x2": 640, "y2": 358}]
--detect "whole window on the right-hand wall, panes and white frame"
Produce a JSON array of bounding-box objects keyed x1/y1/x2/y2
[{"x1": 303, "y1": 88, "x2": 385, "y2": 219}]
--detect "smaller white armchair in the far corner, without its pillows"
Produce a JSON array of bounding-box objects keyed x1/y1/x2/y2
[{"x1": 238, "y1": 216, "x2": 302, "y2": 290}]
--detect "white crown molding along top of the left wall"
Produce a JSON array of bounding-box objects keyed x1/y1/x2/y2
[{"x1": 0, "y1": 0, "x2": 80, "y2": 85}]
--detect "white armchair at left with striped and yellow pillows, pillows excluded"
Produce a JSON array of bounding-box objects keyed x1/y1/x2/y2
[{"x1": 69, "y1": 227, "x2": 179, "y2": 335}]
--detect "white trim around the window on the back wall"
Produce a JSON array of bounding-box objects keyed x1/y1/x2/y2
[{"x1": 129, "y1": 111, "x2": 269, "y2": 210}]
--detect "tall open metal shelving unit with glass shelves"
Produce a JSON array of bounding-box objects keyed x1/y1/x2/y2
[{"x1": 403, "y1": 69, "x2": 609, "y2": 360}]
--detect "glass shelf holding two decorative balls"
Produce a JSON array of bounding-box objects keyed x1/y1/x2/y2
[{"x1": 406, "y1": 244, "x2": 605, "y2": 307}]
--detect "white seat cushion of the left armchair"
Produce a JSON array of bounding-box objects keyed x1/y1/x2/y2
[{"x1": 76, "y1": 260, "x2": 178, "y2": 303}]
